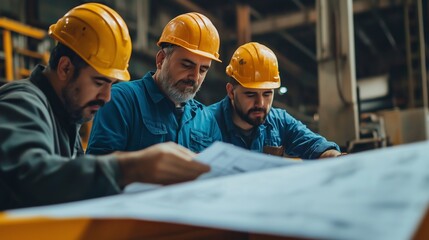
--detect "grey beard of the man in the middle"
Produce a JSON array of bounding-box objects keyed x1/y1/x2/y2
[{"x1": 158, "y1": 62, "x2": 201, "y2": 103}]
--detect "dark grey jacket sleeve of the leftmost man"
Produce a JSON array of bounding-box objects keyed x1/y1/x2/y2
[{"x1": 0, "y1": 89, "x2": 121, "y2": 209}]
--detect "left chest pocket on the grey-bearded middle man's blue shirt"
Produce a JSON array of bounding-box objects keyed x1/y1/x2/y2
[{"x1": 140, "y1": 117, "x2": 168, "y2": 144}]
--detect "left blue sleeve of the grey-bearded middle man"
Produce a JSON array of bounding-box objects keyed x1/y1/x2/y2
[{"x1": 86, "y1": 87, "x2": 132, "y2": 155}]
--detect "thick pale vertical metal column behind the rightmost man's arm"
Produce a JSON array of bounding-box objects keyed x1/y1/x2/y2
[{"x1": 316, "y1": 0, "x2": 359, "y2": 146}]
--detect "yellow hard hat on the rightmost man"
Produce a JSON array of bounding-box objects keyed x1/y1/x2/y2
[{"x1": 226, "y1": 42, "x2": 280, "y2": 89}]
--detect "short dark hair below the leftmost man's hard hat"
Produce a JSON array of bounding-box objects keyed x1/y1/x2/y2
[{"x1": 48, "y1": 43, "x2": 89, "y2": 78}]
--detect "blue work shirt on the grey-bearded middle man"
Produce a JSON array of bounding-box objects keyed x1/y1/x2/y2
[{"x1": 87, "y1": 72, "x2": 222, "y2": 154}]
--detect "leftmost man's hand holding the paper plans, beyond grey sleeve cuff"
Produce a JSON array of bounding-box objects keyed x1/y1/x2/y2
[{"x1": 113, "y1": 142, "x2": 210, "y2": 186}]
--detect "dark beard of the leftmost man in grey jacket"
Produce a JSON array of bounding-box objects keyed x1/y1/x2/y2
[{"x1": 62, "y1": 80, "x2": 105, "y2": 124}]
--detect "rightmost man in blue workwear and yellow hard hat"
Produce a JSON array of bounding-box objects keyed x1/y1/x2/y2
[{"x1": 209, "y1": 42, "x2": 341, "y2": 159}]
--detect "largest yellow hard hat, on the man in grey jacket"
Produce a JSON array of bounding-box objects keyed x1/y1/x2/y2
[{"x1": 49, "y1": 3, "x2": 131, "y2": 80}]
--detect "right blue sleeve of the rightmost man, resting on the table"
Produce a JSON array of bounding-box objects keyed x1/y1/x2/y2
[{"x1": 278, "y1": 111, "x2": 340, "y2": 159}]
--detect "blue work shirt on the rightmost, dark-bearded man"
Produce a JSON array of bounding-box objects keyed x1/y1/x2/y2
[{"x1": 209, "y1": 96, "x2": 340, "y2": 159}]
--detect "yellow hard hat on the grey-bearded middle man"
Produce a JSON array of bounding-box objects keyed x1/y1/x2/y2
[{"x1": 157, "y1": 12, "x2": 222, "y2": 62}]
